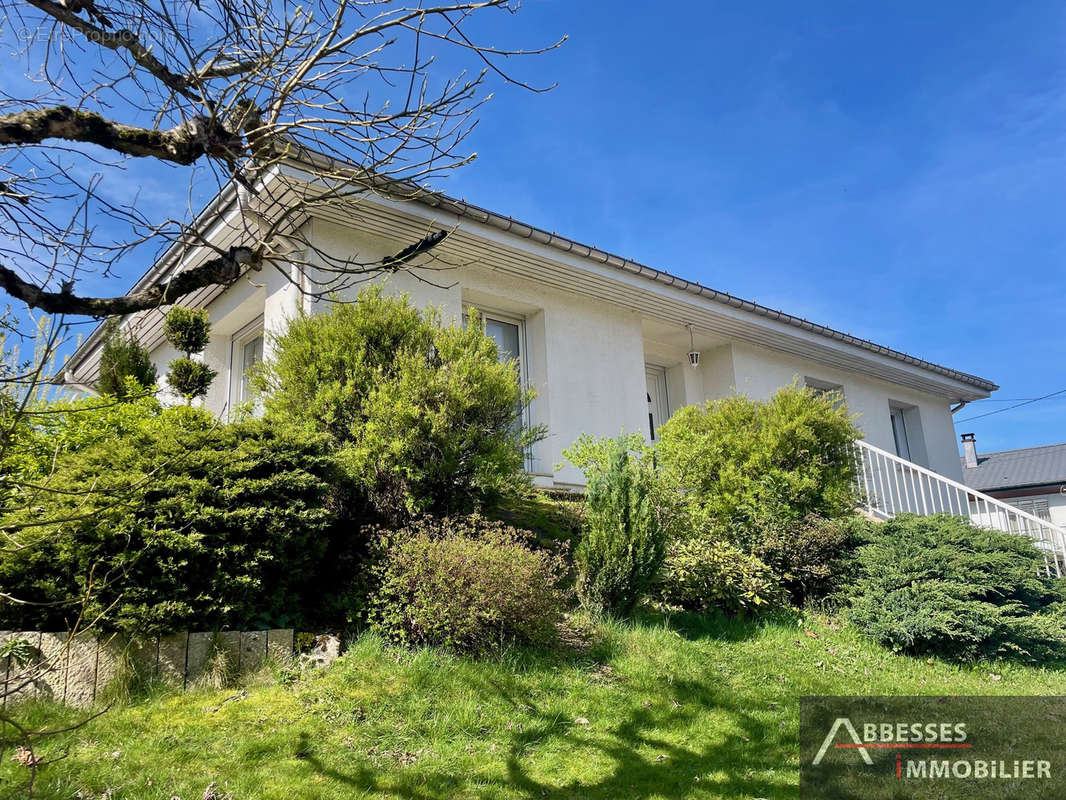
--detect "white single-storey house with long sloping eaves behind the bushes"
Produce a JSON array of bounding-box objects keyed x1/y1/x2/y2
[{"x1": 67, "y1": 165, "x2": 998, "y2": 486}]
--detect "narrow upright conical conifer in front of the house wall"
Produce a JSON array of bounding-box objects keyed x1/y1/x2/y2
[{"x1": 575, "y1": 436, "x2": 666, "y2": 614}]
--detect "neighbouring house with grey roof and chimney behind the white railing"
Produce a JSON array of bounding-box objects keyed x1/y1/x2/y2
[{"x1": 962, "y1": 433, "x2": 1066, "y2": 527}]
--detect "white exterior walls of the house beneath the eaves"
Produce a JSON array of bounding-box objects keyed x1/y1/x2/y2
[{"x1": 152, "y1": 220, "x2": 976, "y2": 486}]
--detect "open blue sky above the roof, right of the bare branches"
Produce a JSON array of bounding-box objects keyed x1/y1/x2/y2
[{"x1": 428, "y1": 0, "x2": 1066, "y2": 450}]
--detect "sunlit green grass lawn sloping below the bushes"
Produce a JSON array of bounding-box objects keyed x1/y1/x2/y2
[{"x1": 6, "y1": 617, "x2": 1066, "y2": 800}]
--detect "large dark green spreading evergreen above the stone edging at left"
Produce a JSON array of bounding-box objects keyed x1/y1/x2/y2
[{"x1": 0, "y1": 407, "x2": 332, "y2": 631}]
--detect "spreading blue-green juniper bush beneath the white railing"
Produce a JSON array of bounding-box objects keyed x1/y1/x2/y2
[{"x1": 849, "y1": 514, "x2": 1066, "y2": 659}]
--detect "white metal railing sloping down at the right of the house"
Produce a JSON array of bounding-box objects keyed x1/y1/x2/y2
[{"x1": 855, "y1": 439, "x2": 1066, "y2": 577}]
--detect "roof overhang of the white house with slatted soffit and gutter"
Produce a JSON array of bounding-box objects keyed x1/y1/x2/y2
[{"x1": 68, "y1": 161, "x2": 999, "y2": 402}]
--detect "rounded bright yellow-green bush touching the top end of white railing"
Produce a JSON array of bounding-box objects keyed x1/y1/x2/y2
[{"x1": 656, "y1": 385, "x2": 859, "y2": 549}]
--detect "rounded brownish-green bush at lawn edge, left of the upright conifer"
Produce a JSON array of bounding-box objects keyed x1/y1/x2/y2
[{"x1": 372, "y1": 517, "x2": 564, "y2": 652}]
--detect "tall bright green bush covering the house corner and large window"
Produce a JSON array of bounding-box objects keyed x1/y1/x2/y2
[{"x1": 255, "y1": 287, "x2": 540, "y2": 523}]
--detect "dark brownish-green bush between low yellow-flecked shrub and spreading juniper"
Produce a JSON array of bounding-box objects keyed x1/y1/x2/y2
[{"x1": 753, "y1": 515, "x2": 871, "y2": 606}]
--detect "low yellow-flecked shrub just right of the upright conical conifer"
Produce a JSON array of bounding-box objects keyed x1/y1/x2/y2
[{"x1": 661, "y1": 538, "x2": 786, "y2": 614}]
